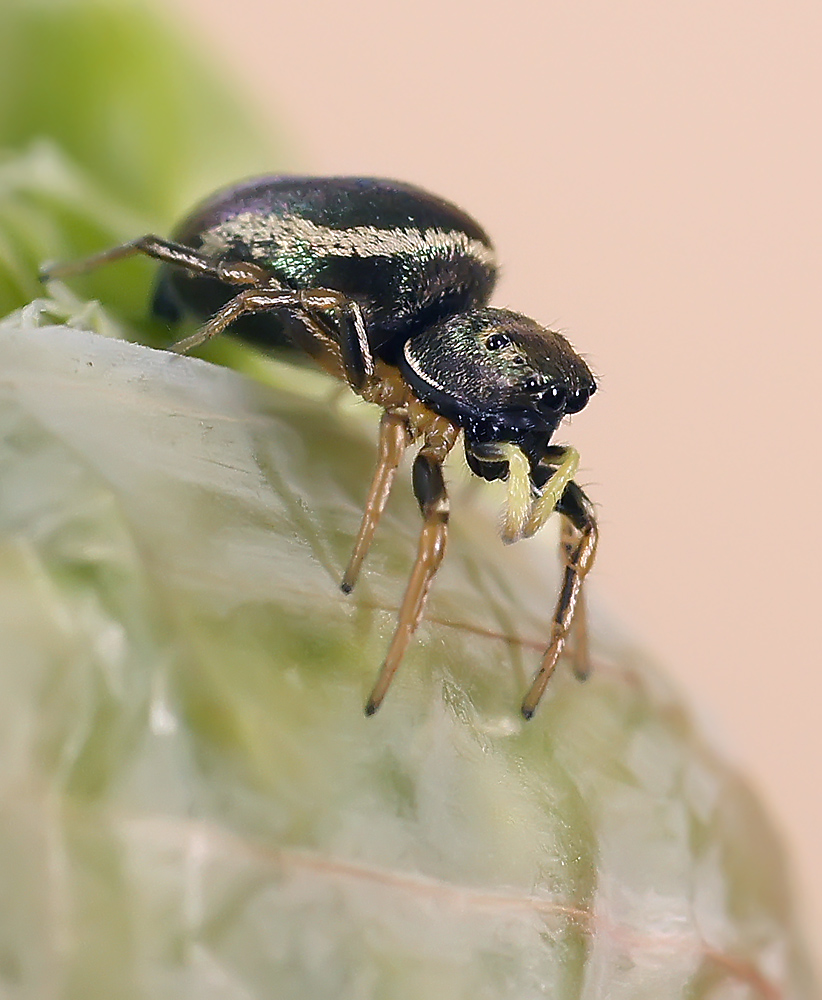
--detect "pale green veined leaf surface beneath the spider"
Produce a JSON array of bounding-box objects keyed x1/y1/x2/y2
[{"x1": 0, "y1": 307, "x2": 812, "y2": 1000}]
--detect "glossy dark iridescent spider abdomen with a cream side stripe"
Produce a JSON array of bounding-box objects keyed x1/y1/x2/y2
[{"x1": 156, "y1": 177, "x2": 496, "y2": 359}]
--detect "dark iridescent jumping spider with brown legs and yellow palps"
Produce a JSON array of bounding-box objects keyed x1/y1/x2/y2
[{"x1": 42, "y1": 177, "x2": 597, "y2": 718}]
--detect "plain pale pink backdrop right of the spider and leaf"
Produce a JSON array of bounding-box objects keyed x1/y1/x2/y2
[{"x1": 176, "y1": 0, "x2": 822, "y2": 948}]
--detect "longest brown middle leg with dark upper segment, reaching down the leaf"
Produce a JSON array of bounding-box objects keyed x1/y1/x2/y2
[{"x1": 365, "y1": 444, "x2": 458, "y2": 715}]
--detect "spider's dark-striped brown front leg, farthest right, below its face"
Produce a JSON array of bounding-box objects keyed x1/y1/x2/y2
[{"x1": 522, "y1": 480, "x2": 598, "y2": 719}]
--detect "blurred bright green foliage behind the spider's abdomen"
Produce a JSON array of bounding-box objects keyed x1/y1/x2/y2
[{"x1": 0, "y1": 0, "x2": 279, "y2": 331}]
